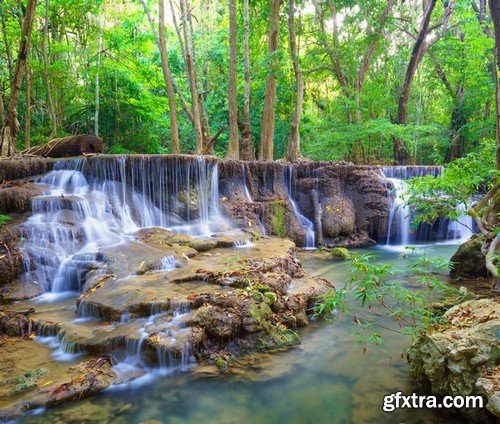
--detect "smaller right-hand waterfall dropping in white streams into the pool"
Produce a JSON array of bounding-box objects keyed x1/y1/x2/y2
[{"x1": 381, "y1": 166, "x2": 474, "y2": 246}]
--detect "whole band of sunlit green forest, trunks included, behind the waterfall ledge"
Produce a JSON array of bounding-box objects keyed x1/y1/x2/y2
[{"x1": 0, "y1": 0, "x2": 495, "y2": 164}]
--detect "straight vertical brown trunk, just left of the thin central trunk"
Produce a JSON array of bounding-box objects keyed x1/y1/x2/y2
[{"x1": 227, "y1": 0, "x2": 240, "y2": 159}]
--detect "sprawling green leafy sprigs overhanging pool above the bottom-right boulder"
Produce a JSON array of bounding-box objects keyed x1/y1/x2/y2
[{"x1": 314, "y1": 253, "x2": 462, "y2": 345}]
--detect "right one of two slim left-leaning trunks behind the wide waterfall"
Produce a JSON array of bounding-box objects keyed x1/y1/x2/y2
[{"x1": 180, "y1": 0, "x2": 204, "y2": 154}]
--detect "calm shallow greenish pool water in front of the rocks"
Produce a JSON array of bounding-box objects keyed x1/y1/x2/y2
[{"x1": 22, "y1": 245, "x2": 462, "y2": 424}]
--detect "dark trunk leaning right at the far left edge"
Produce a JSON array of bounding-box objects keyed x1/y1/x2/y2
[{"x1": 0, "y1": 0, "x2": 36, "y2": 156}]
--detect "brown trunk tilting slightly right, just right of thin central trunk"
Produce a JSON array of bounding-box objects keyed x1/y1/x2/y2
[{"x1": 259, "y1": 0, "x2": 281, "y2": 161}]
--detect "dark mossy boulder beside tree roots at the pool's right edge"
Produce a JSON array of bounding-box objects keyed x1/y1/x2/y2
[{"x1": 450, "y1": 236, "x2": 488, "y2": 278}]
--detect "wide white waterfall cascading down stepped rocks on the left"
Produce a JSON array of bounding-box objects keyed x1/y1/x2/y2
[{"x1": 22, "y1": 156, "x2": 230, "y2": 293}]
